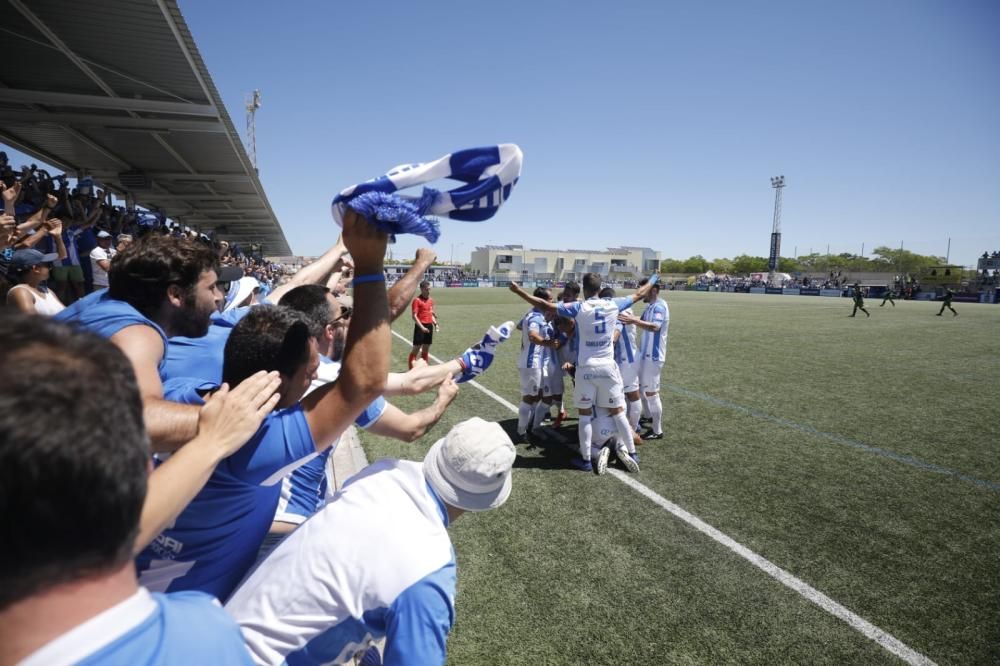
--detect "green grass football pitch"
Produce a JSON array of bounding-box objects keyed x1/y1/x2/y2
[{"x1": 362, "y1": 289, "x2": 1000, "y2": 664}]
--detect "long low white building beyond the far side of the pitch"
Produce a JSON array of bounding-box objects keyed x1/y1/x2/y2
[{"x1": 470, "y1": 245, "x2": 661, "y2": 281}]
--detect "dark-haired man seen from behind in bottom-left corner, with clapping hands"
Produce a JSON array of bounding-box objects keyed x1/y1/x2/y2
[{"x1": 0, "y1": 313, "x2": 263, "y2": 664}]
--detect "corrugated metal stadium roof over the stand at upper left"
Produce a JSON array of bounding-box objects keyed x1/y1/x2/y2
[{"x1": 0, "y1": 0, "x2": 291, "y2": 254}]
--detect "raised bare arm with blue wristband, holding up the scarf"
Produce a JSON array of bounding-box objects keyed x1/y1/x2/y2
[{"x1": 302, "y1": 210, "x2": 392, "y2": 451}]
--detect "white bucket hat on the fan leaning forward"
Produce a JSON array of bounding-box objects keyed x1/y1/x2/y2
[{"x1": 424, "y1": 416, "x2": 517, "y2": 511}]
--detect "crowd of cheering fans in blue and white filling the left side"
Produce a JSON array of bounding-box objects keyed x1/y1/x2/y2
[{"x1": 0, "y1": 179, "x2": 515, "y2": 664}]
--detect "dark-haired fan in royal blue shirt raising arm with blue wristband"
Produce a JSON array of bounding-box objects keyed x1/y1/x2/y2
[{"x1": 136, "y1": 220, "x2": 391, "y2": 599}]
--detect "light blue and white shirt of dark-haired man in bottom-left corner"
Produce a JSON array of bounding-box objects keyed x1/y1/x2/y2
[{"x1": 21, "y1": 588, "x2": 253, "y2": 666}]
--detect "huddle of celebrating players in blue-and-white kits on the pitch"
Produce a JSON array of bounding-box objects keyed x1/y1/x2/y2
[{"x1": 510, "y1": 273, "x2": 670, "y2": 475}]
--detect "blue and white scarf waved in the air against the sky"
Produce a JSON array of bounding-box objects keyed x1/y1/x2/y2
[{"x1": 332, "y1": 143, "x2": 523, "y2": 243}]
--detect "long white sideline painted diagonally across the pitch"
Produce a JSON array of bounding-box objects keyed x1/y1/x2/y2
[{"x1": 392, "y1": 331, "x2": 935, "y2": 666}]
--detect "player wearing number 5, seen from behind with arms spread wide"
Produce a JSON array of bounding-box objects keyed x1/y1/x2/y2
[{"x1": 510, "y1": 273, "x2": 649, "y2": 472}]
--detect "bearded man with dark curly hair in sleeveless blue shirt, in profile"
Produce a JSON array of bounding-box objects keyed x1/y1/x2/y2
[{"x1": 57, "y1": 235, "x2": 238, "y2": 452}]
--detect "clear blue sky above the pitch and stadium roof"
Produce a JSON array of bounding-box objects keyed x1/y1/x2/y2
[{"x1": 7, "y1": 0, "x2": 1000, "y2": 265}]
